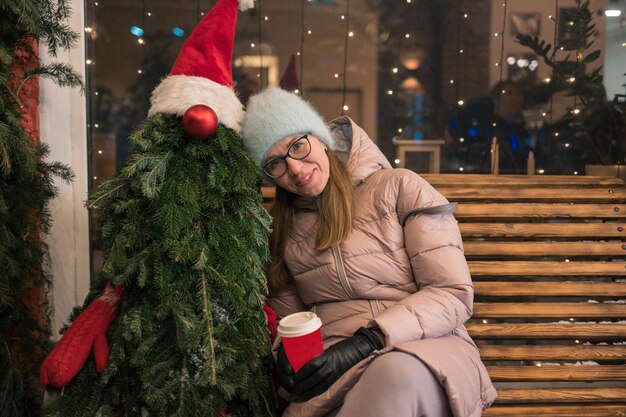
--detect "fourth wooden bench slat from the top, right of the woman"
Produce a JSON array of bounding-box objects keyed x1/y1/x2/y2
[{"x1": 459, "y1": 223, "x2": 626, "y2": 239}]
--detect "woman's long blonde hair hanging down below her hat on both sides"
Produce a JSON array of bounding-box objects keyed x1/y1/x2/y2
[{"x1": 269, "y1": 151, "x2": 354, "y2": 288}]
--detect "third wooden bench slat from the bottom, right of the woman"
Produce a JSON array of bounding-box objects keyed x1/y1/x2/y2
[{"x1": 487, "y1": 365, "x2": 626, "y2": 382}]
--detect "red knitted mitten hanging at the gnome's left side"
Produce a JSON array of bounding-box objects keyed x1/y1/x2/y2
[{"x1": 39, "y1": 282, "x2": 124, "y2": 388}]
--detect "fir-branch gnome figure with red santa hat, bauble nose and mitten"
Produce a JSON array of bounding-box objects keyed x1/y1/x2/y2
[{"x1": 41, "y1": 0, "x2": 274, "y2": 417}]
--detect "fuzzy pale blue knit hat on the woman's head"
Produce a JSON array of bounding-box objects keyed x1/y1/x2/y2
[{"x1": 241, "y1": 87, "x2": 336, "y2": 164}]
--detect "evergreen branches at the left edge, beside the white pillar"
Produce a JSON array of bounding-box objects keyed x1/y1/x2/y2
[{"x1": 0, "y1": 0, "x2": 82, "y2": 417}]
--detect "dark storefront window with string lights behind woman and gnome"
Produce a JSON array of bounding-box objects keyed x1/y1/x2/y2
[{"x1": 86, "y1": 0, "x2": 626, "y2": 275}]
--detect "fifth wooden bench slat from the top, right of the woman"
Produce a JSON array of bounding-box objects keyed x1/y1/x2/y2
[{"x1": 463, "y1": 241, "x2": 626, "y2": 257}]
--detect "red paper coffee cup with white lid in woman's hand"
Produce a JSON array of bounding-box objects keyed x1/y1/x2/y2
[{"x1": 278, "y1": 311, "x2": 324, "y2": 372}]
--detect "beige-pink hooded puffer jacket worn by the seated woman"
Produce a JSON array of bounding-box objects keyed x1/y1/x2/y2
[{"x1": 269, "y1": 117, "x2": 496, "y2": 417}]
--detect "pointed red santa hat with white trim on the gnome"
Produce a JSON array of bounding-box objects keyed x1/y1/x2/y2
[{"x1": 148, "y1": 0, "x2": 254, "y2": 132}]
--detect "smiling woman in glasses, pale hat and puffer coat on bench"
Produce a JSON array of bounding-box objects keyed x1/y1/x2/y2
[{"x1": 242, "y1": 88, "x2": 496, "y2": 417}]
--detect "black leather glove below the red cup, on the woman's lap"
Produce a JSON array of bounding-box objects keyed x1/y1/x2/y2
[{"x1": 290, "y1": 327, "x2": 385, "y2": 400}]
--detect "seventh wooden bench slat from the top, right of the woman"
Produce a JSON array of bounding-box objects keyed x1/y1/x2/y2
[{"x1": 474, "y1": 281, "x2": 626, "y2": 297}]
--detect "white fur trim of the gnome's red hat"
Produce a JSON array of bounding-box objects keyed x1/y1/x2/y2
[{"x1": 148, "y1": 75, "x2": 244, "y2": 132}]
